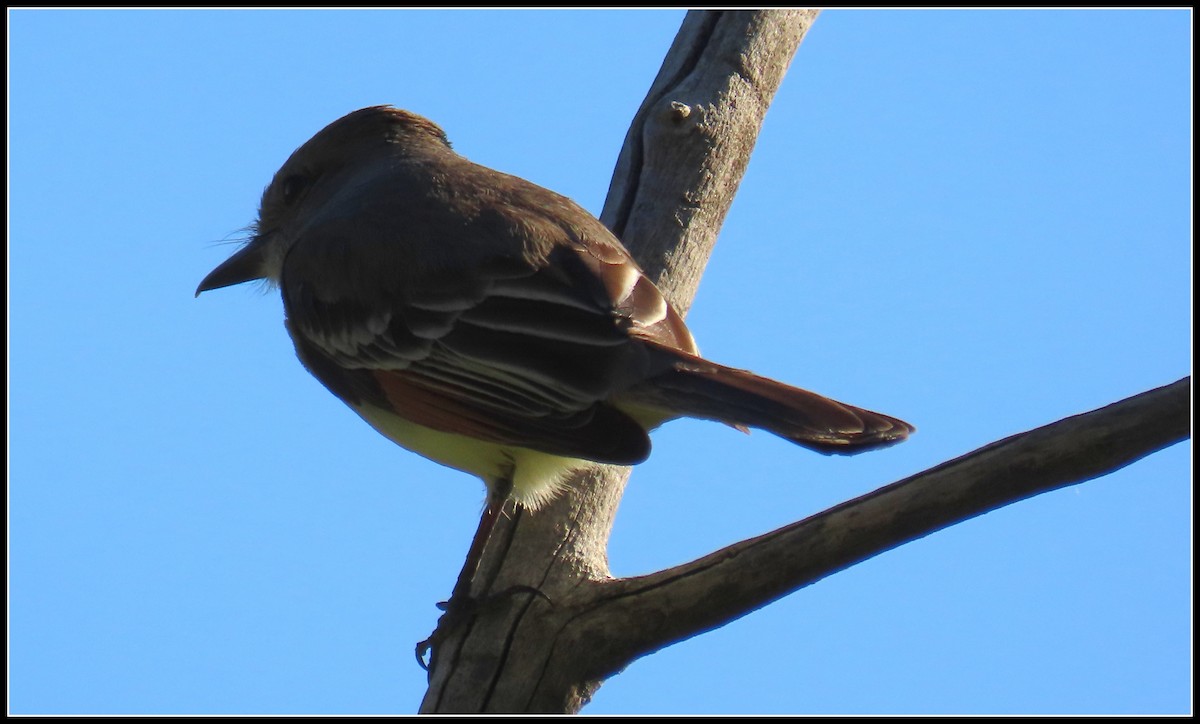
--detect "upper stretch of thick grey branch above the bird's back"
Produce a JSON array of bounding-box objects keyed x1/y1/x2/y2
[{"x1": 600, "y1": 10, "x2": 818, "y2": 312}]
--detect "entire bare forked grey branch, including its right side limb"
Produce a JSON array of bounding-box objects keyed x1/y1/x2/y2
[{"x1": 421, "y1": 11, "x2": 1190, "y2": 712}]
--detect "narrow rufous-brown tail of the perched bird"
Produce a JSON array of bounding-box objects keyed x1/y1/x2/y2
[{"x1": 630, "y1": 351, "x2": 916, "y2": 455}]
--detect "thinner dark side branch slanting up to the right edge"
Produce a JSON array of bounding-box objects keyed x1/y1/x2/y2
[{"x1": 562, "y1": 377, "x2": 1192, "y2": 677}]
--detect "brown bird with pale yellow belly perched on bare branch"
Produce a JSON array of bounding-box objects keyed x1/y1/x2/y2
[{"x1": 196, "y1": 106, "x2": 914, "y2": 602}]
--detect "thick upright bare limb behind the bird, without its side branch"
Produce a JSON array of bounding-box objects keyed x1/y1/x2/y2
[{"x1": 421, "y1": 10, "x2": 817, "y2": 712}]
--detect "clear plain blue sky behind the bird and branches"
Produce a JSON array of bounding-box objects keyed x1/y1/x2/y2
[{"x1": 8, "y1": 11, "x2": 1193, "y2": 713}]
